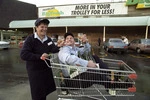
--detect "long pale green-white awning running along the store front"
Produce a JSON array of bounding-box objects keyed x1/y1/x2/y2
[{"x1": 9, "y1": 16, "x2": 150, "y2": 28}]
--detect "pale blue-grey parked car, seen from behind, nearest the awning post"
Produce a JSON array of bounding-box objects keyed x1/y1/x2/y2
[{"x1": 103, "y1": 38, "x2": 128, "y2": 53}]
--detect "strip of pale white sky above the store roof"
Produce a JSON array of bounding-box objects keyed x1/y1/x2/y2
[{"x1": 18, "y1": 0, "x2": 125, "y2": 7}]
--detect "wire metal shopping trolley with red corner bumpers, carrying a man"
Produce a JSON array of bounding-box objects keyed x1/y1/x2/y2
[{"x1": 43, "y1": 54, "x2": 137, "y2": 100}]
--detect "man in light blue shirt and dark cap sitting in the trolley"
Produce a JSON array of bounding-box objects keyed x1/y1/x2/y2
[{"x1": 58, "y1": 32, "x2": 131, "y2": 89}]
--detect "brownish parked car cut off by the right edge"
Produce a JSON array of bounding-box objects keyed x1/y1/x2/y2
[{"x1": 128, "y1": 39, "x2": 150, "y2": 53}]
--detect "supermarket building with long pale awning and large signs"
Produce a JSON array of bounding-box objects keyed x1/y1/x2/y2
[{"x1": 9, "y1": 0, "x2": 150, "y2": 44}]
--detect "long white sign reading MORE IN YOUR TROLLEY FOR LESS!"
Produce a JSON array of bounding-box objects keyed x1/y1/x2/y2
[{"x1": 38, "y1": 3, "x2": 127, "y2": 18}]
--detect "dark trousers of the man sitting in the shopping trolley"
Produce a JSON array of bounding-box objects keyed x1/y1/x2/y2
[{"x1": 64, "y1": 55, "x2": 133, "y2": 88}]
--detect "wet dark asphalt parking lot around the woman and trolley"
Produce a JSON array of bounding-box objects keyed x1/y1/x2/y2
[{"x1": 0, "y1": 47, "x2": 150, "y2": 100}]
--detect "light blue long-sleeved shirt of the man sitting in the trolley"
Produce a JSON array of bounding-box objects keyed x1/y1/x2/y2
[{"x1": 58, "y1": 43, "x2": 91, "y2": 77}]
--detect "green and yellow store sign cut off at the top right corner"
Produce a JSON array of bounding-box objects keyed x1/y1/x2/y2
[{"x1": 126, "y1": 0, "x2": 150, "y2": 9}]
